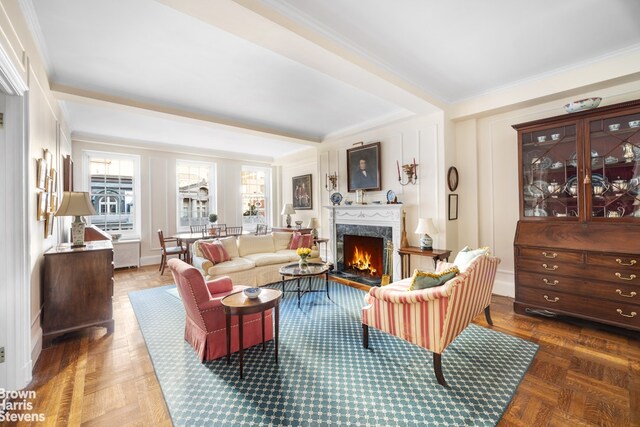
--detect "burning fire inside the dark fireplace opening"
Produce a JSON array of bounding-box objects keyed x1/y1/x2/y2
[{"x1": 343, "y1": 234, "x2": 384, "y2": 278}]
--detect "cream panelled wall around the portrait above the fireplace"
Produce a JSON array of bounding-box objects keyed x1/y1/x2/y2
[{"x1": 315, "y1": 113, "x2": 448, "y2": 269}]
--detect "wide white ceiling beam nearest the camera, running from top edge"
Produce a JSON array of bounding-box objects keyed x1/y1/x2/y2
[{"x1": 156, "y1": 0, "x2": 446, "y2": 114}]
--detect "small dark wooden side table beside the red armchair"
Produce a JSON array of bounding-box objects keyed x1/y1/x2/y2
[{"x1": 220, "y1": 288, "x2": 282, "y2": 378}]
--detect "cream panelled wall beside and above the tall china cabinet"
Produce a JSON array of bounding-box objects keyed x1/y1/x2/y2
[{"x1": 455, "y1": 80, "x2": 640, "y2": 297}]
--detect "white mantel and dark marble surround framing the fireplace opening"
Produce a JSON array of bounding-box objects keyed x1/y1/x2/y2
[{"x1": 325, "y1": 204, "x2": 404, "y2": 282}]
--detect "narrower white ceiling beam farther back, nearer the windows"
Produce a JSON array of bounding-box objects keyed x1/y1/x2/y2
[{"x1": 50, "y1": 83, "x2": 321, "y2": 146}]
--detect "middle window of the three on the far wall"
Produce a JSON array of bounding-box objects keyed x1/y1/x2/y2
[{"x1": 176, "y1": 160, "x2": 217, "y2": 231}]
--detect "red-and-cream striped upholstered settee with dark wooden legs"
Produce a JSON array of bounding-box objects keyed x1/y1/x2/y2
[{"x1": 362, "y1": 255, "x2": 500, "y2": 386}]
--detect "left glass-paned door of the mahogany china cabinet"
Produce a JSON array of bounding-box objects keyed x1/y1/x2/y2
[{"x1": 522, "y1": 124, "x2": 582, "y2": 217}]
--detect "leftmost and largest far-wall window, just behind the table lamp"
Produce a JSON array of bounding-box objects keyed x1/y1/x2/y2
[{"x1": 84, "y1": 151, "x2": 140, "y2": 235}]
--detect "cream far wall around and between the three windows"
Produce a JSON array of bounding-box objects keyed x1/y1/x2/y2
[{"x1": 72, "y1": 139, "x2": 280, "y2": 265}]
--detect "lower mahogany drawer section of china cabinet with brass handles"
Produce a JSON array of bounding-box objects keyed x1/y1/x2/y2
[{"x1": 514, "y1": 224, "x2": 640, "y2": 330}]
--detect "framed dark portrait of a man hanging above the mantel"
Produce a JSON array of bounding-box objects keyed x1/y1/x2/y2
[{"x1": 347, "y1": 142, "x2": 382, "y2": 192}]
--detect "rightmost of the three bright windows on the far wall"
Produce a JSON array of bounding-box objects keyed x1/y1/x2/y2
[{"x1": 240, "y1": 166, "x2": 271, "y2": 231}]
